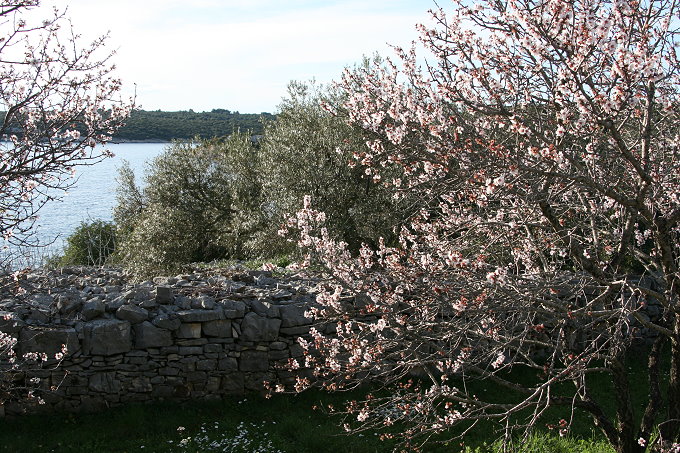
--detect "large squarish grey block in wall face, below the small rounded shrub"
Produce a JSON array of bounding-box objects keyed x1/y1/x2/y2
[{"x1": 83, "y1": 319, "x2": 132, "y2": 356}]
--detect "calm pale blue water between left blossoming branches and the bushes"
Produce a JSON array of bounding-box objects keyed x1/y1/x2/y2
[{"x1": 36, "y1": 143, "x2": 167, "y2": 252}]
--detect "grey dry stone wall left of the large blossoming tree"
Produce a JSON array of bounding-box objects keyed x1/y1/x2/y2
[{"x1": 0, "y1": 268, "x2": 316, "y2": 414}]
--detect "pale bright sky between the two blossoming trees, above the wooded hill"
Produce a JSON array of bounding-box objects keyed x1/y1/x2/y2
[{"x1": 41, "y1": 0, "x2": 435, "y2": 113}]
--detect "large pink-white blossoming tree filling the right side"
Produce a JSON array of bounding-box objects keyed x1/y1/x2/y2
[{"x1": 290, "y1": 0, "x2": 680, "y2": 452}]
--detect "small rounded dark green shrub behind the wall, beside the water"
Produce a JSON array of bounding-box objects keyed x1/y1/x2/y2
[{"x1": 48, "y1": 220, "x2": 117, "y2": 267}]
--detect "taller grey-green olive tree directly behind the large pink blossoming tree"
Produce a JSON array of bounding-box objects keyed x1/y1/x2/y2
[{"x1": 261, "y1": 82, "x2": 406, "y2": 252}]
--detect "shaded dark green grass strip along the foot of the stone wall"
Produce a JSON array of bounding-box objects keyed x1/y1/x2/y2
[{"x1": 0, "y1": 392, "x2": 398, "y2": 453}]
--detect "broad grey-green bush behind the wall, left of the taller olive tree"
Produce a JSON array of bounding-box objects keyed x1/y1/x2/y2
[{"x1": 114, "y1": 133, "x2": 265, "y2": 277}]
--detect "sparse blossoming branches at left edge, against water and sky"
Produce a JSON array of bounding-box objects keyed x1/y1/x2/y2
[{"x1": 0, "y1": 0, "x2": 132, "y2": 260}]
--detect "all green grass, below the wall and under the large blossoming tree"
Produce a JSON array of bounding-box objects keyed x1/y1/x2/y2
[{"x1": 0, "y1": 348, "x2": 660, "y2": 453}]
